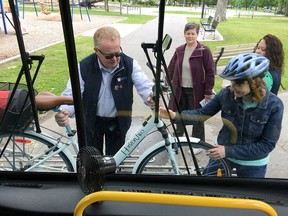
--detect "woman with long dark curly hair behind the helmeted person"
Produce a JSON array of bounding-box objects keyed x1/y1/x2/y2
[{"x1": 254, "y1": 34, "x2": 284, "y2": 95}]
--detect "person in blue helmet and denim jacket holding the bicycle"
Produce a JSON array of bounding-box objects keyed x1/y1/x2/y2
[{"x1": 160, "y1": 53, "x2": 284, "y2": 178}]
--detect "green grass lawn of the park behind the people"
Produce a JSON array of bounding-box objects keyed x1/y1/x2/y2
[{"x1": 0, "y1": 8, "x2": 288, "y2": 95}]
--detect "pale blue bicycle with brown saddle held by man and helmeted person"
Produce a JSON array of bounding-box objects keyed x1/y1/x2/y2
[{"x1": 0, "y1": 88, "x2": 228, "y2": 176}]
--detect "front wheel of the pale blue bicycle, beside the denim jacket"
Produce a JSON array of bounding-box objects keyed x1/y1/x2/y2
[{"x1": 135, "y1": 141, "x2": 231, "y2": 177}]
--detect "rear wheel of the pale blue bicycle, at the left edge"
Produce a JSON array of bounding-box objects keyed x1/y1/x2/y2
[{"x1": 0, "y1": 132, "x2": 75, "y2": 172}]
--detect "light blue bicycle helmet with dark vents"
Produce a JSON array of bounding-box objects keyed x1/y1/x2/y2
[{"x1": 220, "y1": 53, "x2": 270, "y2": 80}]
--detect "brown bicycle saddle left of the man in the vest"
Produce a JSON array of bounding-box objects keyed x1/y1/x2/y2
[{"x1": 35, "y1": 92, "x2": 73, "y2": 111}]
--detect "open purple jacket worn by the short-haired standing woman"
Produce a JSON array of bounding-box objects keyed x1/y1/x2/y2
[{"x1": 168, "y1": 42, "x2": 215, "y2": 111}]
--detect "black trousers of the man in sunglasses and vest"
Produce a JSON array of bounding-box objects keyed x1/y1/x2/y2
[{"x1": 92, "y1": 116, "x2": 125, "y2": 155}]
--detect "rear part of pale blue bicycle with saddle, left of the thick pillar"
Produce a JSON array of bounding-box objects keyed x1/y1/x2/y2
[{"x1": 0, "y1": 92, "x2": 79, "y2": 172}]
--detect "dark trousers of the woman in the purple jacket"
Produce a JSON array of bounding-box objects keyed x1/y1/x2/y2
[{"x1": 176, "y1": 87, "x2": 205, "y2": 141}]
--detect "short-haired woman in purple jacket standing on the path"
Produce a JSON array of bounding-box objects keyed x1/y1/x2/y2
[{"x1": 168, "y1": 22, "x2": 215, "y2": 141}]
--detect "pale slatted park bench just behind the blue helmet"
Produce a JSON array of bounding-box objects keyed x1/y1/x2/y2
[{"x1": 213, "y1": 43, "x2": 257, "y2": 74}]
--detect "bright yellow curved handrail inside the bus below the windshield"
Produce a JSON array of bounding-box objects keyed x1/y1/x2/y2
[{"x1": 74, "y1": 191, "x2": 277, "y2": 216}]
